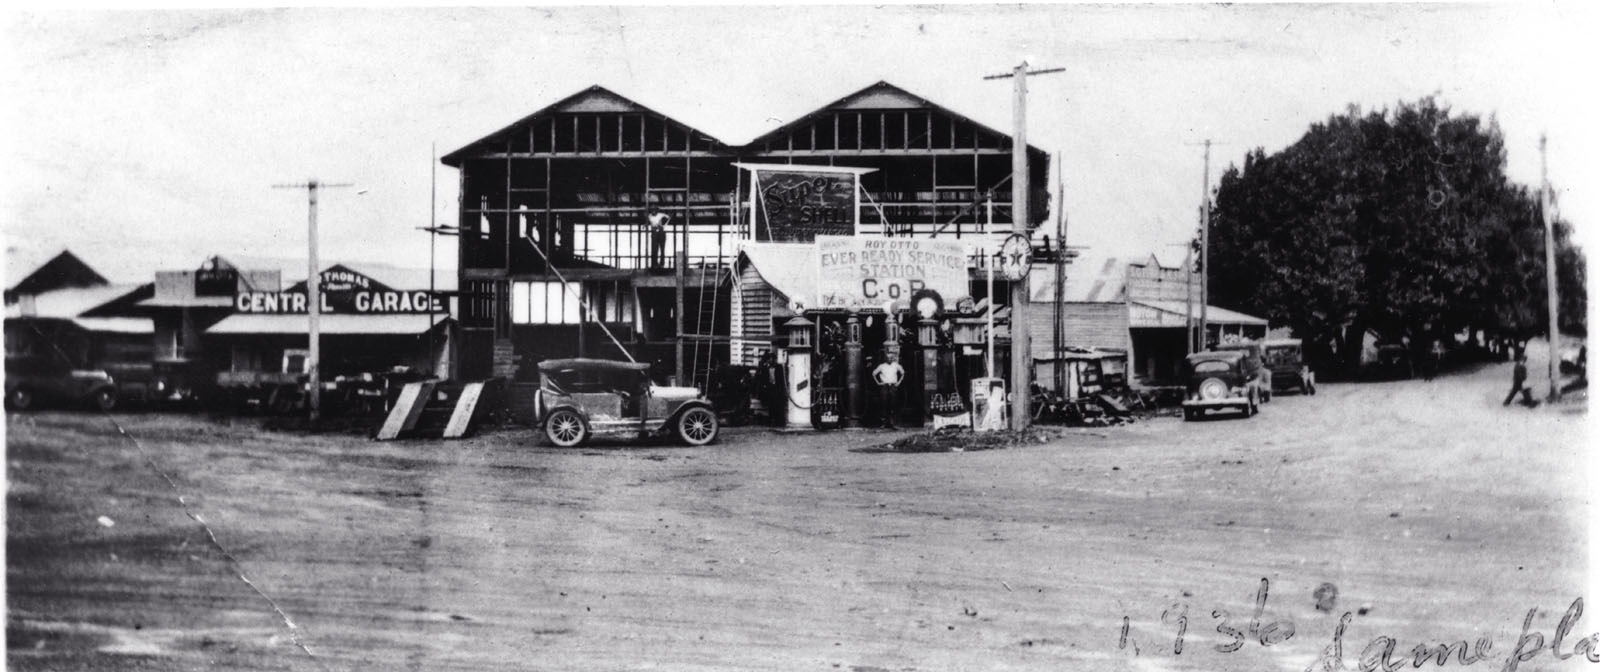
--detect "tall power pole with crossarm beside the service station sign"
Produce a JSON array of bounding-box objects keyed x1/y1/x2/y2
[{"x1": 984, "y1": 61, "x2": 1066, "y2": 429}]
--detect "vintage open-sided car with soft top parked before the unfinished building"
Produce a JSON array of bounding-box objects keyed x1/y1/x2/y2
[{"x1": 534, "y1": 358, "x2": 720, "y2": 448}]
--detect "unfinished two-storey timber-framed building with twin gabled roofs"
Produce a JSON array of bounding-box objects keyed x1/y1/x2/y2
[{"x1": 442, "y1": 82, "x2": 1050, "y2": 384}]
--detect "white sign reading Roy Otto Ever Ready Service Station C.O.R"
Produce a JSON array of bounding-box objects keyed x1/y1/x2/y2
[{"x1": 816, "y1": 235, "x2": 970, "y2": 309}]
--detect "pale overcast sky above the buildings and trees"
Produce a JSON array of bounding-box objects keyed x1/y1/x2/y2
[{"x1": 0, "y1": 2, "x2": 1600, "y2": 285}]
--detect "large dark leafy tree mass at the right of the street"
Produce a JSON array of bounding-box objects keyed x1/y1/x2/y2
[{"x1": 1208, "y1": 98, "x2": 1584, "y2": 372}]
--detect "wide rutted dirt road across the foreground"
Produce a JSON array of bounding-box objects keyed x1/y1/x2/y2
[{"x1": 6, "y1": 365, "x2": 1600, "y2": 670}]
